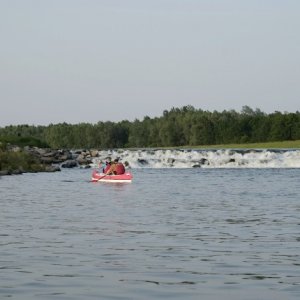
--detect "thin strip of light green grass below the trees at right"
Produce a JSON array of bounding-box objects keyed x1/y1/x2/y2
[{"x1": 188, "y1": 140, "x2": 300, "y2": 149}]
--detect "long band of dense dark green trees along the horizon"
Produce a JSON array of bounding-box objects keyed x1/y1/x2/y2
[{"x1": 0, "y1": 105, "x2": 300, "y2": 149}]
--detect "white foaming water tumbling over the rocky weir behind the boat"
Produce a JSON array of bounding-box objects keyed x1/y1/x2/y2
[{"x1": 91, "y1": 149, "x2": 300, "y2": 168}]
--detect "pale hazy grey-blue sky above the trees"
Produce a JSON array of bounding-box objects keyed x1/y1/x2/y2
[{"x1": 0, "y1": 0, "x2": 300, "y2": 126}]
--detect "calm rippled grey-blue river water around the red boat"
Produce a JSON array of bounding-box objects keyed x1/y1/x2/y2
[{"x1": 0, "y1": 169, "x2": 300, "y2": 300}]
